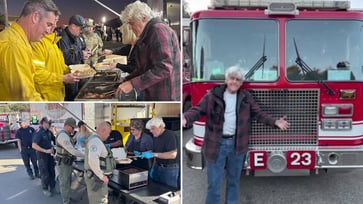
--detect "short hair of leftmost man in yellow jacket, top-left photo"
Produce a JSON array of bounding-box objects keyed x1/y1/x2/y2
[{"x1": 20, "y1": 0, "x2": 61, "y2": 18}]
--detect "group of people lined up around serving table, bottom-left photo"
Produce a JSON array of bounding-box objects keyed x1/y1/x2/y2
[{"x1": 16, "y1": 117, "x2": 180, "y2": 203}]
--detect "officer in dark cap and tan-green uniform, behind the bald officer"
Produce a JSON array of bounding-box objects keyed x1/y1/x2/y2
[{"x1": 56, "y1": 118, "x2": 84, "y2": 204}]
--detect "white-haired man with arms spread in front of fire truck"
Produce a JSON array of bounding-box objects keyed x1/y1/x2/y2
[{"x1": 183, "y1": 67, "x2": 289, "y2": 204}]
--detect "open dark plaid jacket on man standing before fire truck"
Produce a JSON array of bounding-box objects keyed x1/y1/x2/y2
[{"x1": 184, "y1": 84, "x2": 275, "y2": 162}]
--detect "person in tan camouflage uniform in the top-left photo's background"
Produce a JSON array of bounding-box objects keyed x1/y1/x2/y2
[{"x1": 82, "y1": 18, "x2": 103, "y2": 66}]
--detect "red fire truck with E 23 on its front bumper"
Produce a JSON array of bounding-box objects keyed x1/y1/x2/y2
[{"x1": 183, "y1": 0, "x2": 363, "y2": 176}]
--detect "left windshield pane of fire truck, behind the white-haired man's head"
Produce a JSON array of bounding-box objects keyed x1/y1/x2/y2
[{"x1": 192, "y1": 19, "x2": 279, "y2": 82}]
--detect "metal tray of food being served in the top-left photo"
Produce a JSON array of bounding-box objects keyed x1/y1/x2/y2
[{"x1": 75, "y1": 69, "x2": 123, "y2": 100}]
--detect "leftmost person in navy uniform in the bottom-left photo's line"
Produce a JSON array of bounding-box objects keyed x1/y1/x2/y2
[{"x1": 16, "y1": 120, "x2": 40, "y2": 179}]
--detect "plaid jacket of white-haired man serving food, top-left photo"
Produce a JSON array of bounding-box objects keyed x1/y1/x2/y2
[{"x1": 131, "y1": 18, "x2": 180, "y2": 101}]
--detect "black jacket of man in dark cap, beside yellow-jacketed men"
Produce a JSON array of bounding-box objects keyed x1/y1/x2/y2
[{"x1": 58, "y1": 27, "x2": 85, "y2": 65}]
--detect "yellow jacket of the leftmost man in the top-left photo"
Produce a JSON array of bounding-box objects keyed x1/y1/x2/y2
[{"x1": 0, "y1": 23, "x2": 42, "y2": 101}]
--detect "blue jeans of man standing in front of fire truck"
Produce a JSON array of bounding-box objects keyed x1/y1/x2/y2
[{"x1": 205, "y1": 139, "x2": 245, "y2": 204}]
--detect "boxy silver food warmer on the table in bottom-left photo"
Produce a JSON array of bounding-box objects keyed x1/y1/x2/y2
[{"x1": 113, "y1": 165, "x2": 149, "y2": 190}]
